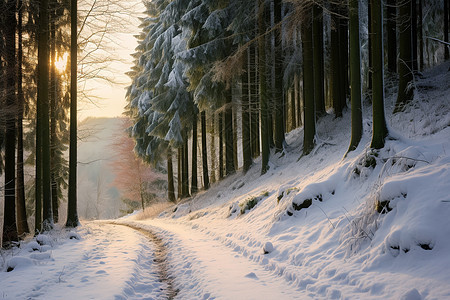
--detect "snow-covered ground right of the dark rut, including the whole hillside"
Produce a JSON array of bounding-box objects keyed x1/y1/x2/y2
[{"x1": 119, "y1": 64, "x2": 450, "y2": 299}]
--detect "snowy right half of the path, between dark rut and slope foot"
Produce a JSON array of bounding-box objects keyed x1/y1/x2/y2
[{"x1": 117, "y1": 220, "x2": 308, "y2": 300}]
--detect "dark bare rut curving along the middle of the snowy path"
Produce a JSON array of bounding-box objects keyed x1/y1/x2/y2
[{"x1": 110, "y1": 223, "x2": 178, "y2": 300}]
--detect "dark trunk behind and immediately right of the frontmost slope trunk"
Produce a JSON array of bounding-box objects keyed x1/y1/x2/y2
[{"x1": 386, "y1": 0, "x2": 397, "y2": 73}]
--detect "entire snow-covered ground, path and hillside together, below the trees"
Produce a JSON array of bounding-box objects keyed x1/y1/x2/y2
[{"x1": 0, "y1": 63, "x2": 450, "y2": 300}]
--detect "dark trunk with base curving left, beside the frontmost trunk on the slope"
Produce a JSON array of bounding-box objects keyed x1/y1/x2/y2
[{"x1": 348, "y1": 0, "x2": 362, "y2": 151}]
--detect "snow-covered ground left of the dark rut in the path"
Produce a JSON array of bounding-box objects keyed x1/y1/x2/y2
[{"x1": 0, "y1": 221, "x2": 170, "y2": 300}]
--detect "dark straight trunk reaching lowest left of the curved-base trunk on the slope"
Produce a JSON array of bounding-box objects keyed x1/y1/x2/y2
[{"x1": 301, "y1": 8, "x2": 316, "y2": 155}]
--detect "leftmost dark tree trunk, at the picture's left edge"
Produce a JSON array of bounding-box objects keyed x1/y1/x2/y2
[{"x1": 2, "y1": 0, "x2": 18, "y2": 247}]
